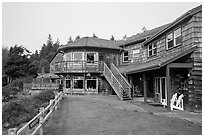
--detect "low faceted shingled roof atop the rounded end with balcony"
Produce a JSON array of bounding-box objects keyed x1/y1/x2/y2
[{"x1": 58, "y1": 37, "x2": 122, "y2": 50}]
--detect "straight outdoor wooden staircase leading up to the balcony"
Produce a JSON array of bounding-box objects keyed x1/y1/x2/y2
[{"x1": 103, "y1": 63, "x2": 131, "y2": 100}]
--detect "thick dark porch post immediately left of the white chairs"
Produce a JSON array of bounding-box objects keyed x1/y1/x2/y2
[{"x1": 166, "y1": 65, "x2": 171, "y2": 112}]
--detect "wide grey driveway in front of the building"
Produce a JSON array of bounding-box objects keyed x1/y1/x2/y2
[{"x1": 44, "y1": 96, "x2": 202, "y2": 135}]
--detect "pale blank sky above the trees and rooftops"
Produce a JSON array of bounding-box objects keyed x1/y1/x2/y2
[{"x1": 2, "y1": 2, "x2": 201, "y2": 52}]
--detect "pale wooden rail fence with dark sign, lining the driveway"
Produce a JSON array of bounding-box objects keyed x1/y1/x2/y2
[{"x1": 8, "y1": 92, "x2": 63, "y2": 135}]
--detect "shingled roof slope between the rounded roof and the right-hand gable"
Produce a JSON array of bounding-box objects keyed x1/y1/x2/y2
[{"x1": 118, "y1": 24, "x2": 169, "y2": 46}]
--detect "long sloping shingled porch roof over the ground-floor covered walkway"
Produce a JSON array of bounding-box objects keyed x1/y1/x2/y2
[{"x1": 118, "y1": 46, "x2": 197, "y2": 74}]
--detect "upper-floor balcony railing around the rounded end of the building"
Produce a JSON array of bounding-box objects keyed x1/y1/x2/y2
[{"x1": 55, "y1": 61, "x2": 103, "y2": 73}]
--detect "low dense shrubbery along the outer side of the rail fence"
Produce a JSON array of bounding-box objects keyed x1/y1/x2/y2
[{"x1": 2, "y1": 90, "x2": 55, "y2": 128}]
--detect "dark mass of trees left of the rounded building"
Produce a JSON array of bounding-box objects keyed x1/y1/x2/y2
[{"x1": 2, "y1": 34, "x2": 60, "y2": 86}]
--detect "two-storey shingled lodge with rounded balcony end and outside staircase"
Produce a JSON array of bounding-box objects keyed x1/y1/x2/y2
[{"x1": 32, "y1": 5, "x2": 202, "y2": 111}]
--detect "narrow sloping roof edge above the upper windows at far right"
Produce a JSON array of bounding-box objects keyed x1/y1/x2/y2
[{"x1": 143, "y1": 5, "x2": 202, "y2": 45}]
